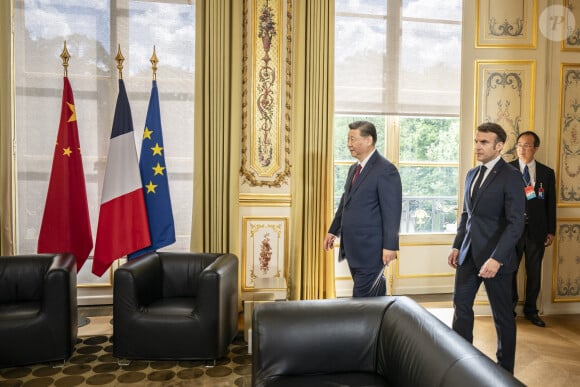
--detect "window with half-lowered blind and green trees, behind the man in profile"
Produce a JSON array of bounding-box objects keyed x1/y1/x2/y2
[{"x1": 334, "y1": 0, "x2": 461, "y2": 233}]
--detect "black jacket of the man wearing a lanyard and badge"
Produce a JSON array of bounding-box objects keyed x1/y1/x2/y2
[{"x1": 510, "y1": 160, "x2": 556, "y2": 243}]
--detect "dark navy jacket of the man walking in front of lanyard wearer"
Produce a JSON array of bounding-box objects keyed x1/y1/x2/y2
[{"x1": 453, "y1": 158, "x2": 525, "y2": 273}]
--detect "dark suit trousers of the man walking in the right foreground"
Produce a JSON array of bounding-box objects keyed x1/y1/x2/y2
[{"x1": 453, "y1": 252, "x2": 516, "y2": 374}]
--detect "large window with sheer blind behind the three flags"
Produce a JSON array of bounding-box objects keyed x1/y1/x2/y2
[{"x1": 14, "y1": 0, "x2": 195, "y2": 260}]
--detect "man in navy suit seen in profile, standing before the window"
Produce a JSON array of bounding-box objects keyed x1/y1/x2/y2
[{"x1": 324, "y1": 121, "x2": 402, "y2": 297}]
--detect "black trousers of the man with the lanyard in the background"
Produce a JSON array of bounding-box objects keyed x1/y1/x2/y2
[{"x1": 512, "y1": 225, "x2": 546, "y2": 315}]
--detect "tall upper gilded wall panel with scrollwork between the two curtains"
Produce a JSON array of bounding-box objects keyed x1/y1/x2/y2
[{"x1": 240, "y1": 0, "x2": 292, "y2": 187}]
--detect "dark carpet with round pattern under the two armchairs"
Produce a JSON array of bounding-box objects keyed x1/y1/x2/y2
[{"x1": 0, "y1": 335, "x2": 252, "y2": 387}]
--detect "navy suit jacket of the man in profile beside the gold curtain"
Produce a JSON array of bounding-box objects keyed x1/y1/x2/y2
[{"x1": 329, "y1": 151, "x2": 402, "y2": 268}]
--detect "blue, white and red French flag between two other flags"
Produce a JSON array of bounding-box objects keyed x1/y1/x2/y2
[{"x1": 92, "y1": 79, "x2": 151, "y2": 277}]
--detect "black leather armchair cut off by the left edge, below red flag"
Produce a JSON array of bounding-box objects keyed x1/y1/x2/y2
[{"x1": 0, "y1": 254, "x2": 78, "y2": 368}]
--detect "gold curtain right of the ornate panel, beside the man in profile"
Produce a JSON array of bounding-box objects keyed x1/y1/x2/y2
[{"x1": 288, "y1": 0, "x2": 336, "y2": 299}]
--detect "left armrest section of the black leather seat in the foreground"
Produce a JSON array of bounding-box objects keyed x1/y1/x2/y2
[{"x1": 252, "y1": 298, "x2": 392, "y2": 381}]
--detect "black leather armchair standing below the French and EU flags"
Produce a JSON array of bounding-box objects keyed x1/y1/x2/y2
[{"x1": 113, "y1": 252, "x2": 238, "y2": 360}]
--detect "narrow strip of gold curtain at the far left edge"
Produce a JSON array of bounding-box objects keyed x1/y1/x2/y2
[{"x1": 0, "y1": 1, "x2": 14, "y2": 255}]
